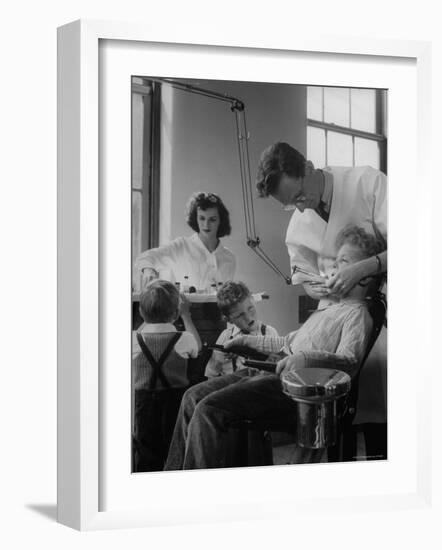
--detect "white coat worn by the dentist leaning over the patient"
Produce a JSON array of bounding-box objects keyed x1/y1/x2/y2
[{"x1": 286, "y1": 166, "x2": 387, "y2": 423}]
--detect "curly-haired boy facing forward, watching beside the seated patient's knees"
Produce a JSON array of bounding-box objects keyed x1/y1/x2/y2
[{"x1": 205, "y1": 281, "x2": 278, "y2": 378}]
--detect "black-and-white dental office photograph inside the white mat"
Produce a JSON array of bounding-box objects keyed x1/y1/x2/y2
[{"x1": 130, "y1": 75, "x2": 388, "y2": 473}]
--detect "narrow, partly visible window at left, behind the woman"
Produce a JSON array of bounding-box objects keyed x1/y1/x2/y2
[{"x1": 132, "y1": 77, "x2": 161, "y2": 259}]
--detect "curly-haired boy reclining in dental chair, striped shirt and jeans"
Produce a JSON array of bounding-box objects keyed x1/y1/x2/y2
[{"x1": 165, "y1": 226, "x2": 384, "y2": 470}]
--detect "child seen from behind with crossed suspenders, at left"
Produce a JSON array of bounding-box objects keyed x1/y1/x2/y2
[{"x1": 132, "y1": 280, "x2": 201, "y2": 472}]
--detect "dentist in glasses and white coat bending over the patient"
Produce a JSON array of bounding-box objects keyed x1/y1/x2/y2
[{"x1": 256, "y1": 142, "x2": 387, "y2": 300}]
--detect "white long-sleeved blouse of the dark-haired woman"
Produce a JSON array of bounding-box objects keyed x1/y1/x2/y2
[{"x1": 134, "y1": 233, "x2": 236, "y2": 292}]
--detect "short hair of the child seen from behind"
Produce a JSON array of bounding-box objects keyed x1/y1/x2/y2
[{"x1": 140, "y1": 279, "x2": 180, "y2": 323}]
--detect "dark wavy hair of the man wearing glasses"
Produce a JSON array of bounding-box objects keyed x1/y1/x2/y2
[{"x1": 255, "y1": 141, "x2": 305, "y2": 197}]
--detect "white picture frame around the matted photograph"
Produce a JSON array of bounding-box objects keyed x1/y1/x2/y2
[{"x1": 58, "y1": 21, "x2": 434, "y2": 530}]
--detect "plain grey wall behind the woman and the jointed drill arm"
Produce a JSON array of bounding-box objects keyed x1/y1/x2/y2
[{"x1": 161, "y1": 81, "x2": 306, "y2": 334}]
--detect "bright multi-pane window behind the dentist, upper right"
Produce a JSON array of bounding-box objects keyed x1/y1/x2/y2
[{"x1": 307, "y1": 86, "x2": 387, "y2": 173}]
